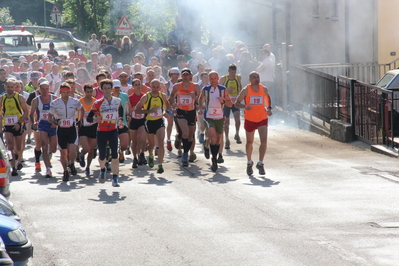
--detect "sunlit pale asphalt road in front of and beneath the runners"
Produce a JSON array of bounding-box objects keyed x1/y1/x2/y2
[{"x1": 10, "y1": 119, "x2": 399, "y2": 266}]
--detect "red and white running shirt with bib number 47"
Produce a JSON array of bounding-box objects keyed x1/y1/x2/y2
[{"x1": 91, "y1": 96, "x2": 122, "y2": 131}]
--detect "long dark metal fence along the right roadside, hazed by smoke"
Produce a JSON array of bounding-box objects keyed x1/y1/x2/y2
[{"x1": 284, "y1": 65, "x2": 399, "y2": 147}]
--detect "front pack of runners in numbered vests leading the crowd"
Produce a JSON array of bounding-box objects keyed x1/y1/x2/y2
[{"x1": 0, "y1": 52, "x2": 272, "y2": 187}]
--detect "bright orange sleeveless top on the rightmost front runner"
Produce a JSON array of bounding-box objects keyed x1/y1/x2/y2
[{"x1": 244, "y1": 84, "x2": 267, "y2": 122}]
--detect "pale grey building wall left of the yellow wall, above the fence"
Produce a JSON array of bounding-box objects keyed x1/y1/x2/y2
[{"x1": 290, "y1": 0, "x2": 376, "y2": 64}]
